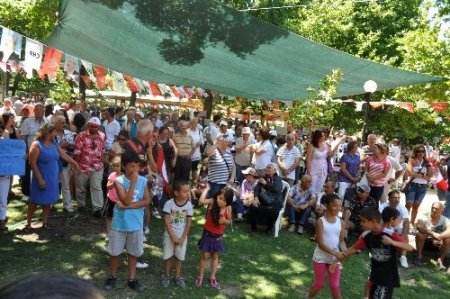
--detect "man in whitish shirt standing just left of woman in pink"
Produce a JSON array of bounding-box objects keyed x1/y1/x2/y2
[{"x1": 277, "y1": 134, "x2": 301, "y2": 186}]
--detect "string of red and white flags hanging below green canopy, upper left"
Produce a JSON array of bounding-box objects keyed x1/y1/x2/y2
[{"x1": 0, "y1": 25, "x2": 214, "y2": 99}]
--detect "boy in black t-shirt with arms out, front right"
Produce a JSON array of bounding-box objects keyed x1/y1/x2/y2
[{"x1": 343, "y1": 207, "x2": 413, "y2": 299}]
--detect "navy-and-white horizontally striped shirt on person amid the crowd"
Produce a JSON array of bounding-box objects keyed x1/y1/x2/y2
[{"x1": 208, "y1": 149, "x2": 234, "y2": 185}]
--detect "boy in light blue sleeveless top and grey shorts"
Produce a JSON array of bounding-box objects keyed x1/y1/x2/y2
[{"x1": 105, "y1": 152, "x2": 150, "y2": 292}]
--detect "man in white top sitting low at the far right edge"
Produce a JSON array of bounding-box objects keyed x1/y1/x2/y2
[{"x1": 414, "y1": 201, "x2": 450, "y2": 271}]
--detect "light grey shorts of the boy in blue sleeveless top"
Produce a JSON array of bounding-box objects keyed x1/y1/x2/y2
[{"x1": 106, "y1": 230, "x2": 144, "y2": 257}]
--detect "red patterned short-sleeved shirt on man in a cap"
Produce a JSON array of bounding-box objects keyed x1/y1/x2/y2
[{"x1": 74, "y1": 130, "x2": 106, "y2": 173}]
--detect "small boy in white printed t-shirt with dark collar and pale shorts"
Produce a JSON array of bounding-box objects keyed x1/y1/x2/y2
[{"x1": 162, "y1": 181, "x2": 194, "y2": 288}]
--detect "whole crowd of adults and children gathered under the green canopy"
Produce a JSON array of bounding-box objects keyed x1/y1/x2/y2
[{"x1": 0, "y1": 99, "x2": 450, "y2": 298}]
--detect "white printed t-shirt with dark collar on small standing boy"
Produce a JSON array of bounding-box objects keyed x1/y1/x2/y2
[{"x1": 163, "y1": 198, "x2": 194, "y2": 238}]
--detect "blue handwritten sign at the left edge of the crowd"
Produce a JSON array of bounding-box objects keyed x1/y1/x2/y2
[{"x1": 0, "y1": 139, "x2": 26, "y2": 175}]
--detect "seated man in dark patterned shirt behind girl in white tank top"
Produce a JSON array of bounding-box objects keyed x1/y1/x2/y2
[{"x1": 342, "y1": 183, "x2": 378, "y2": 238}]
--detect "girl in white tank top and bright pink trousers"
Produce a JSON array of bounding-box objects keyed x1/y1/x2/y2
[{"x1": 308, "y1": 193, "x2": 347, "y2": 298}]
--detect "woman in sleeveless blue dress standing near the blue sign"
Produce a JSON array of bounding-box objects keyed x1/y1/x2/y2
[{"x1": 25, "y1": 124, "x2": 78, "y2": 229}]
